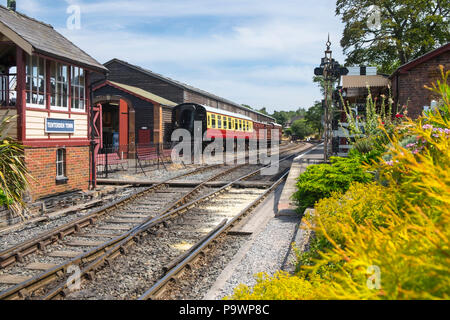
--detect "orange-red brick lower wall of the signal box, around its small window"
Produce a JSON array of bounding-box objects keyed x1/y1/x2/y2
[{"x1": 25, "y1": 146, "x2": 89, "y2": 201}]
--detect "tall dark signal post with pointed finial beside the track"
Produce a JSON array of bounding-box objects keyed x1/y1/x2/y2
[{"x1": 314, "y1": 34, "x2": 348, "y2": 162}]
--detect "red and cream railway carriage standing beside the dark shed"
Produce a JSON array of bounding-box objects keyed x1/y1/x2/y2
[{"x1": 172, "y1": 103, "x2": 281, "y2": 147}]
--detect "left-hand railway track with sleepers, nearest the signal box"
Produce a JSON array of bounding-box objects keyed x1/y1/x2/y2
[{"x1": 0, "y1": 142, "x2": 312, "y2": 299}]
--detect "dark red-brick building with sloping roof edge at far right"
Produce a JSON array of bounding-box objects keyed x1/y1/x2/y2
[{"x1": 389, "y1": 43, "x2": 450, "y2": 118}]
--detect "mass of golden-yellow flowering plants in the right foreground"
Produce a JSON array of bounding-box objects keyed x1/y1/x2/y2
[{"x1": 229, "y1": 66, "x2": 450, "y2": 300}]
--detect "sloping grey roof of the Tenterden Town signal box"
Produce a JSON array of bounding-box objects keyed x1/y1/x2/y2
[{"x1": 0, "y1": 6, "x2": 108, "y2": 73}]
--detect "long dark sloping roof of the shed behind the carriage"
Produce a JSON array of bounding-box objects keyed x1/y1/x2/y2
[{"x1": 105, "y1": 59, "x2": 275, "y2": 120}]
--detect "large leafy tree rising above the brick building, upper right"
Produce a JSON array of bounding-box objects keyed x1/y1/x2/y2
[{"x1": 336, "y1": 0, "x2": 450, "y2": 74}]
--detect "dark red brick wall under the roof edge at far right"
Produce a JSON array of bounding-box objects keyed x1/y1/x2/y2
[{"x1": 392, "y1": 51, "x2": 450, "y2": 119}]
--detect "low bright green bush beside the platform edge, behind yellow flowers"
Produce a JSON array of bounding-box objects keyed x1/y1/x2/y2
[{"x1": 293, "y1": 157, "x2": 373, "y2": 213}]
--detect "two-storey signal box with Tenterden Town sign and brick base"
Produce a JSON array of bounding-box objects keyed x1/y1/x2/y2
[{"x1": 0, "y1": 6, "x2": 107, "y2": 200}]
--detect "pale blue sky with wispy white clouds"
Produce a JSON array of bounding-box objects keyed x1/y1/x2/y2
[{"x1": 13, "y1": 0, "x2": 345, "y2": 112}]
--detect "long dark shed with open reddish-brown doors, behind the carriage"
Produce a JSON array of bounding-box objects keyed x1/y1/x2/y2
[{"x1": 92, "y1": 59, "x2": 275, "y2": 149}]
